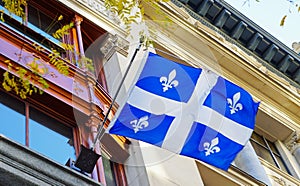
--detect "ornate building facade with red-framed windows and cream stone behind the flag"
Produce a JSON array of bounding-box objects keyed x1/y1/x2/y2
[{"x1": 0, "y1": 0, "x2": 300, "y2": 186}]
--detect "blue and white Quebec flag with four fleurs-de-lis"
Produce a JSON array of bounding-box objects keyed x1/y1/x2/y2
[{"x1": 107, "y1": 53, "x2": 259, "y2": 170}]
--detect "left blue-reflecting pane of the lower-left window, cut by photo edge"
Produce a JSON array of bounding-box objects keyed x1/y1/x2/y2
[{"x1": 0, "y1": 92, "x2": 25, "y2": 145}]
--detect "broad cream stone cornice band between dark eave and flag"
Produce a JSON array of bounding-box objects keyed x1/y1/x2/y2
[{"x1": 142, "y1": 2, "x2": 300, "y2": 129}]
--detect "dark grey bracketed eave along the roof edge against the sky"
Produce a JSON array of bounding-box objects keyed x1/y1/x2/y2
[{"x1": 171, "y1": 0, "x2": 300, "y2": 88}]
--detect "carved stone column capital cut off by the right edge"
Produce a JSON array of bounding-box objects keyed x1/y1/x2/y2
[{"x1": 286, "y1": 131, "x2": 300, "y2": 165}]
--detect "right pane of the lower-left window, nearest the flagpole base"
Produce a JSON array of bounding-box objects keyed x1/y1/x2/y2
[{"x1": 29, "y1": 108, "x2": 76, "y2": 164}]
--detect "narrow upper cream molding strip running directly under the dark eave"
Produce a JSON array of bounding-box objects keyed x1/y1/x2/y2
[{"x1": 163, "y1": 2, "x2": 300, "y2": 96}]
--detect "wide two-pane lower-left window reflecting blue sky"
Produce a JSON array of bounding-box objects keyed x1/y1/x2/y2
[{"x1": 0, "y1": 91, "x2": 75, "y2": 164}]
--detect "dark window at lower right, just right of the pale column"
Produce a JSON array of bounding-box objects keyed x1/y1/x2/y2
[{"x1": 251, "y1": 132, "x2": 289, "y2": 173}]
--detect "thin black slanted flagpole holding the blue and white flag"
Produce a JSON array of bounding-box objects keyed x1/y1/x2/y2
[{"x1": 91, "y1": 40, "x2": 142, "y2": 149}]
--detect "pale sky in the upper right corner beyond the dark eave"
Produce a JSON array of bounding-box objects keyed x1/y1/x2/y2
[{"x1": 225, "y1": 0, "x2": 300, "y2": 48}]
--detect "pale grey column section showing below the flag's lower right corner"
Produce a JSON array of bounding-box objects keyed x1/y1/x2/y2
[{"x1": 234, "y1": 141, "x2": 272, "y2": 185}]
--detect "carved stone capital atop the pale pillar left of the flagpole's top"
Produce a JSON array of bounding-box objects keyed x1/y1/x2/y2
[{"x1": 100, "y1": 34, "x2": 129, "y2": 60}]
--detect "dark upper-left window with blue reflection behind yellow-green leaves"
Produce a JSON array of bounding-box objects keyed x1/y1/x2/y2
[{"x1": 0, "y1": 0, "x2": 74, "y2": 50}]
